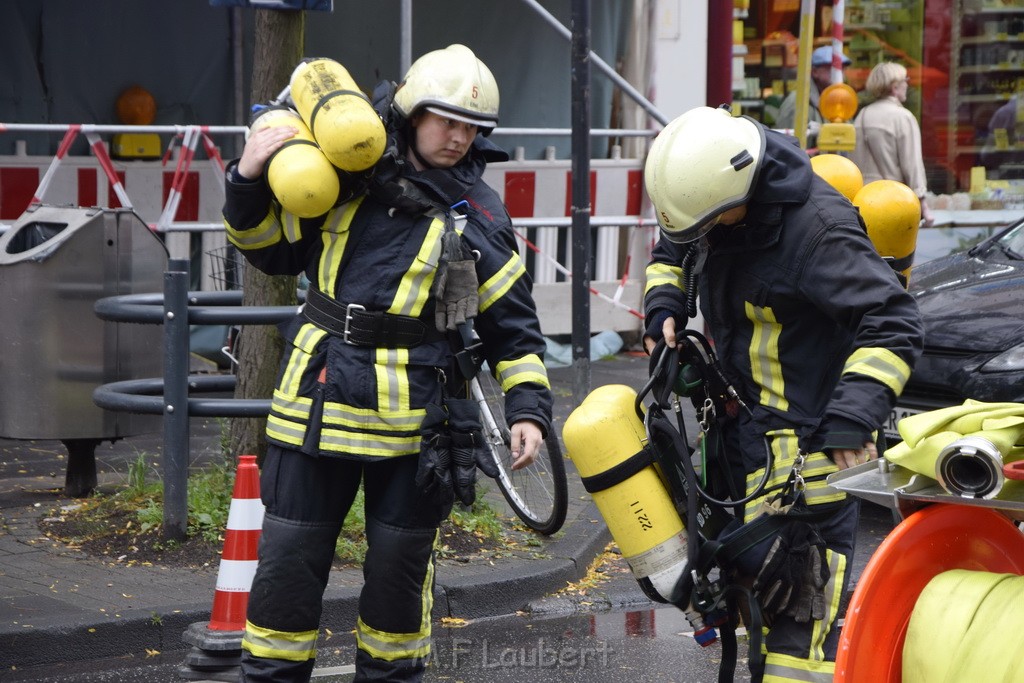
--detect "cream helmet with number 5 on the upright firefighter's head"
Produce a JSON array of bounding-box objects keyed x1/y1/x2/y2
[{"x1": 394, "y1": 43, "x2": 499, "y2": 135}]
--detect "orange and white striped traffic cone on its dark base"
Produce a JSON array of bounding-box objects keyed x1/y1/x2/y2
[{"x1": 178, "y1": 456, "x2": 263, "y2": 681}]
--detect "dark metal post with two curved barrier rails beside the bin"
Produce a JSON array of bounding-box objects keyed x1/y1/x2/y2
[{"x1": 92, "y1": 259, "x2": 296, "y2": 541}]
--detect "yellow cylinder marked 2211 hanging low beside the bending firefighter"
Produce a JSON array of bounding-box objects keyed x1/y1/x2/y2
[{"x1": 562, "y1": 384, "x2": 687, "y2": 599}]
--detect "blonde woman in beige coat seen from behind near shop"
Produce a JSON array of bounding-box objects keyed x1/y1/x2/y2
[{"x1": 850, "y1": 61, "x2": 933, "y2": 226}]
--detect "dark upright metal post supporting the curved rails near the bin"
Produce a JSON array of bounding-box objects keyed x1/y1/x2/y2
[{"x1": 163, "y1": 259, "x2": 188, "y2": 541}]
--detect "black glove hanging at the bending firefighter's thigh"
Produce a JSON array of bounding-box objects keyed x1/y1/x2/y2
[{"x1": 754, "y1": 520, "x2": 829, "y2": 624}]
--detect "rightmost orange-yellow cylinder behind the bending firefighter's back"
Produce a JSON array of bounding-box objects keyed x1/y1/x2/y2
[{"x1": 853, "y1": 180, "x2": 921, "y2": 287}]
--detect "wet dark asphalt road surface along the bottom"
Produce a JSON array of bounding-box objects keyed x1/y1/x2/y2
[{"x1": 6, "y1": 607, "x2": 749, "y2": 683}]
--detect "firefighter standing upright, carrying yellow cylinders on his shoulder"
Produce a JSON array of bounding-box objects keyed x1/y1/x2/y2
[{"x1": 223, "y1": 44, "x2": 552, "y2": 683}]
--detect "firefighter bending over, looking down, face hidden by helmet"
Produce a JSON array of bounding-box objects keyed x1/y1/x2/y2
[{"x1": 644, "y1": 108, "x2": 923, "y2": 682}]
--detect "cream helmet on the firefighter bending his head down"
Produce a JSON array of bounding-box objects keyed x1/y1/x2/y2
[{"x1": 644, "y1": 106, "x2": 765, "y2": 243}]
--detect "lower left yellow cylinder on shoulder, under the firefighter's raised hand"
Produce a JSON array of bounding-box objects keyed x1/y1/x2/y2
[{"x1": 249, "y1": 105, "x2": 341, "y2": 218}]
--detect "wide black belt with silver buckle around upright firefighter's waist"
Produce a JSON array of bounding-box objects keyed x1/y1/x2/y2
[{"x1": 302, "y1": 288, "x2": 444, "y2": 348}]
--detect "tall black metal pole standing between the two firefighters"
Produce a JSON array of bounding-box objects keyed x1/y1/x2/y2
[{"x1": 571, "y1": 0, "x2": 591, "y2": 405}]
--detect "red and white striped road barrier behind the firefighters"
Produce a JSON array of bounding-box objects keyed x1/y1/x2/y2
[{"x1": 0, "y1": 123, "x2": 656, "y2": 334}]
